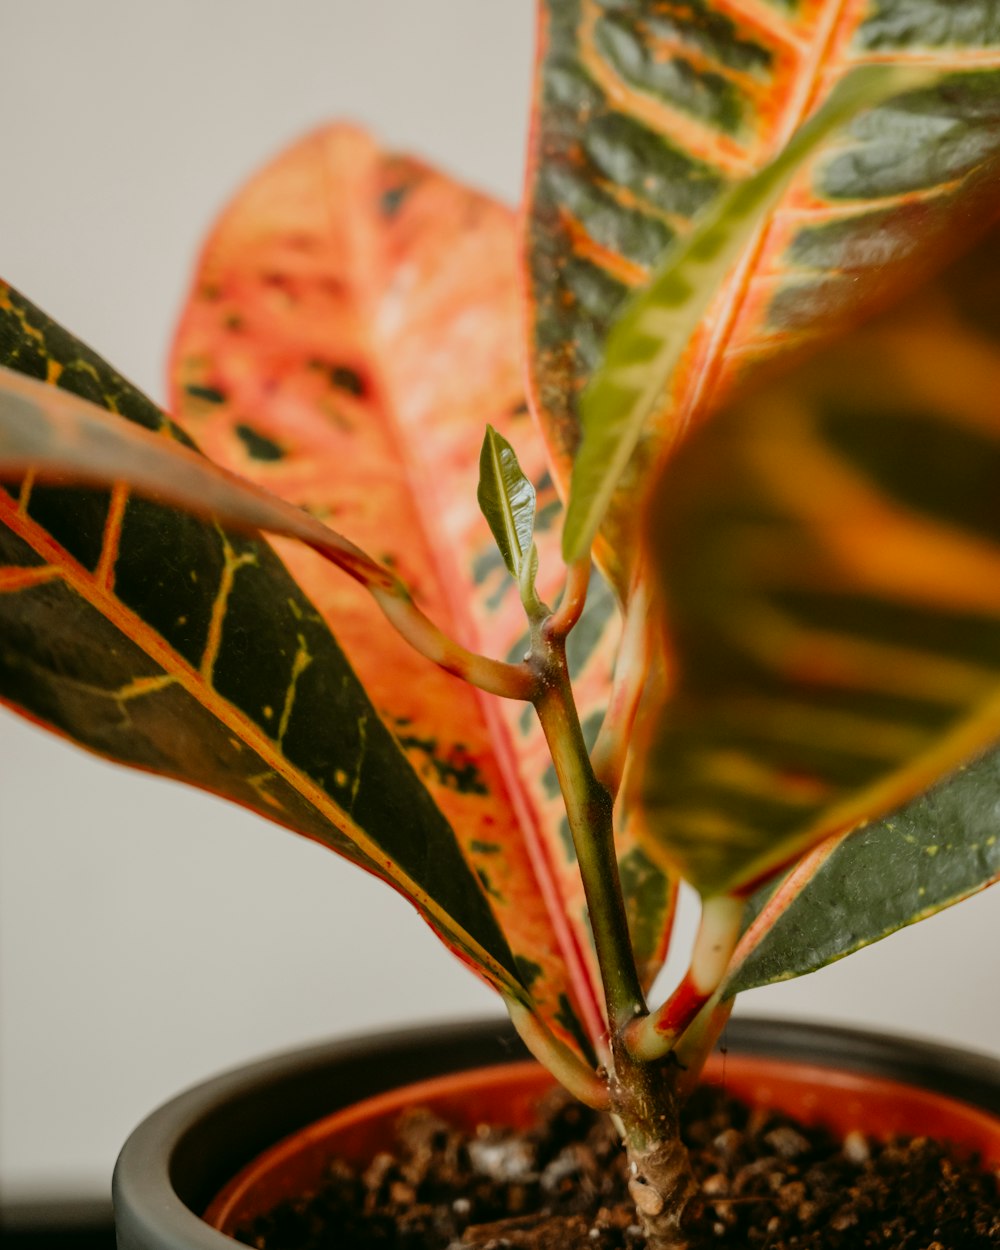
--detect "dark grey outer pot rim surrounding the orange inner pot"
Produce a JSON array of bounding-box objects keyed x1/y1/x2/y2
[{"x1": 113, "y1": 1018, "x2": 1000, "y2": 1250}]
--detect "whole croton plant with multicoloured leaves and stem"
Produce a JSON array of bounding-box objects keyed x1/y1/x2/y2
[{"x1": 0, "y1": 0, "x2": 1000, "y2": 1248}]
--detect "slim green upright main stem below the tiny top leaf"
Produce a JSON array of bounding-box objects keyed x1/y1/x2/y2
[{"x1": 530, "y1": 618, "x2": 645, "y2": 1036}]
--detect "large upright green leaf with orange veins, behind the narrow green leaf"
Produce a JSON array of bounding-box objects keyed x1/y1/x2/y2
[{"x1": 525, "y1": 0, "x2": 1000, "y2": 589}]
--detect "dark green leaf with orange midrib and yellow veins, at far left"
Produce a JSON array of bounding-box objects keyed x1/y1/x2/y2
[{"x1": 0, "y1": 278, "x2": 526, "y2": 999}]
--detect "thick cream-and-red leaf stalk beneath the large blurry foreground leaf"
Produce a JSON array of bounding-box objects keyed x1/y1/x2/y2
[{"x1": 626, "y1": 894, "x2": 745, "y2": 1061}]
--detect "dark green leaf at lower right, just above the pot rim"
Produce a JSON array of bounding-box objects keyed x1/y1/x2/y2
[{"x1": 721, "y1": 750, "x2": 1000, "y2": 998}]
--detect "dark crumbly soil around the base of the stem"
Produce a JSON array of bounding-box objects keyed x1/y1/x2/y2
[{"x1": 239, "y1": 1090, "x2": 1000, "y2": 1250}]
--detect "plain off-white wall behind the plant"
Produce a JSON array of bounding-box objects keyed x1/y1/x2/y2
[{"x1": 0, "y1": 0, "x2": 1000, "y2": 1201}]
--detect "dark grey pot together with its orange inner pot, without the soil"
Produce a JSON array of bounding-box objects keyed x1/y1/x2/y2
[{"x1": 114, "y1": 1020, "x2": 1000, "y2": 1250}]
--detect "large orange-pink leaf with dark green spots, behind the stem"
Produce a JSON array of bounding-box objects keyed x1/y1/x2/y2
[{"x1": 173, "y1": 126, "x2": 673, "y2": 1040}]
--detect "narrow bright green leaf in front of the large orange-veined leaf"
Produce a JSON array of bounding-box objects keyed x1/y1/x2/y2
[{"x1": 563, "y1": 66, "x2": 928, "y2": 560}]
